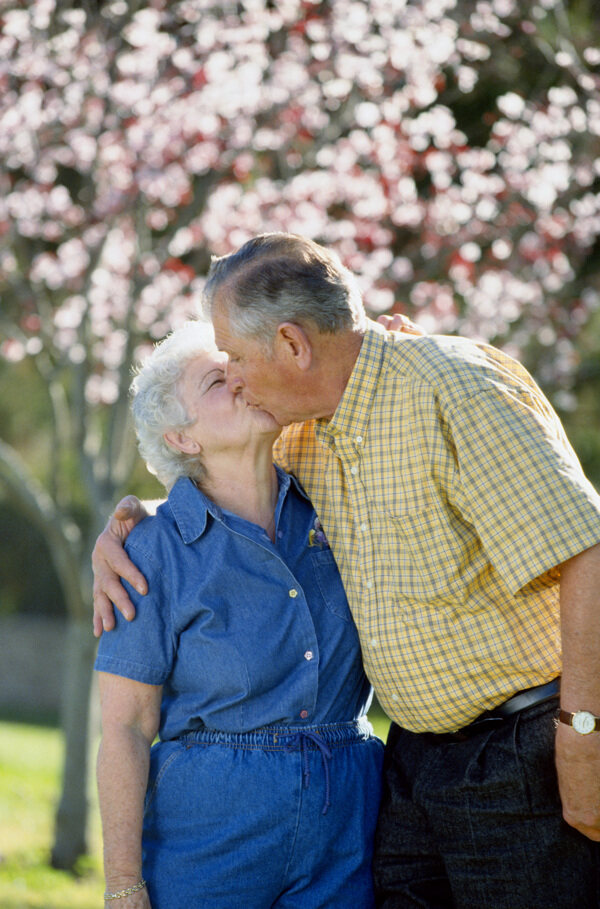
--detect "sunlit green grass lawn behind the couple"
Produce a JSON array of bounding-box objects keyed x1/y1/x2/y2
[{"x1": 0, "y1": 705, "x2": 389, "y2": 909}]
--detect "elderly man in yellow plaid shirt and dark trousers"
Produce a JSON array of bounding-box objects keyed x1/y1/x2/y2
[{"x1": 95, "y1": 234, "x2": 600, "y2": 909}]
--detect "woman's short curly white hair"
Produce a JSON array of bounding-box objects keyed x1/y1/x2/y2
[{"x1": 131, "y1": 321, "x2": 215, "y2": 490}]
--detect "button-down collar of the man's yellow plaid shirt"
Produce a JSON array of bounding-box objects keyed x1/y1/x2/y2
[{"x1": 315, "y1": 320, "x2": 387, "y2": 444}]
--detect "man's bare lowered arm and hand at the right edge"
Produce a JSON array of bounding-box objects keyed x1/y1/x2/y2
[{"x1": 556, "y1": 544, "x2": 600, "y2": 842}]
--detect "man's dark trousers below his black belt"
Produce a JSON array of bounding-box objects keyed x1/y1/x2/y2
[{"x1": 374, "y1": 700, "x2": 600, "y2": 909}]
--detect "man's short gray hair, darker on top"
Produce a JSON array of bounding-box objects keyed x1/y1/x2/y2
[{"x1": 204, "y1": 233, "x2": 366, "y2": 346}]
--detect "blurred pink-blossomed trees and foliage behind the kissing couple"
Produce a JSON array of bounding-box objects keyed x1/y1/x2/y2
[{"x1": 0, "y1": 0, "x2": 600, "y2": 866}]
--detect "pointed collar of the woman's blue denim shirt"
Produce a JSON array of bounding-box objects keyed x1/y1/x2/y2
[{"x1": 168, "y1": 465, "x2": 309, "y2": 543}]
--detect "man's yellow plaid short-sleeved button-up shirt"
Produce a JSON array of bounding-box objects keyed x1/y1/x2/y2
[{"x1": 276, "y1": 323, "x2": 600, "y2": 732}]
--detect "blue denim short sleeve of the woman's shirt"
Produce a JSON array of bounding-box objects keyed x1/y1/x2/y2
[{"x1": 94, "y1": 548, "x2": 175, "y2": 685}]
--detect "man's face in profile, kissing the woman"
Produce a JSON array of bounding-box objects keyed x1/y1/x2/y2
[{"x1": 212, "y1": 303, "x2": 303, "y2": 426}]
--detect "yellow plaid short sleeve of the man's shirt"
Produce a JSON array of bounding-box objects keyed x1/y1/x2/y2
[{"x1": 451, "y1": 386, "x2": 600, "y2": 593}]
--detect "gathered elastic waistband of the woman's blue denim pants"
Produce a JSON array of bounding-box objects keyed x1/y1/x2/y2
[{"x1": 177, "y1": 717, "x2": 373, "y2": 751}]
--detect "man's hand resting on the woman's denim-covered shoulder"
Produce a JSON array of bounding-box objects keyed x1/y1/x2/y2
[{"x1": 92, "y1": 496, "x2": 148, "y2": 637}]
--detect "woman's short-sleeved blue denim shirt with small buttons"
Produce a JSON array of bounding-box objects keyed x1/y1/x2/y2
[{"x1": 95, "y1": 469, "x2": 371, "y2": 740}]
